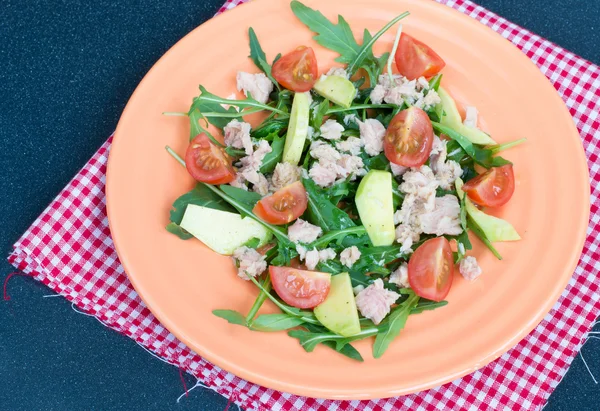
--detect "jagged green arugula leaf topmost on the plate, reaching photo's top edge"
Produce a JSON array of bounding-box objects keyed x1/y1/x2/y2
[{"x1": 291, "y1": 0, "x2": 360, "y2": 63}]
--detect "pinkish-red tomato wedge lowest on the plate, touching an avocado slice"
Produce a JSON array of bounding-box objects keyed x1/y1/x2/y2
[{"x1": 269, "y1": 266, "x2": 331, "y2": 308}]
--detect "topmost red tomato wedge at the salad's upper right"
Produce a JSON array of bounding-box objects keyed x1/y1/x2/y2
[{"x1": 395, "y1": 33, "x2": 446, "y2": 80}]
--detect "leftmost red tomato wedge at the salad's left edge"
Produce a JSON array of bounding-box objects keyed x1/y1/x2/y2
[{"x1": 185, "y1": 134, "x2": 235, "y2": 184}]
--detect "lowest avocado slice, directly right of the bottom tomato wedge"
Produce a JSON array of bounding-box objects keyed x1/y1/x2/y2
[{"x1": 314, "y1": 273, "x2": 360, "y2": 337}]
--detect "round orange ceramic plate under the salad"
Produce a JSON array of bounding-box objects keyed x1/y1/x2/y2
[{"x1": 107, "y1": 0, "x2": 589, "y2": 399}]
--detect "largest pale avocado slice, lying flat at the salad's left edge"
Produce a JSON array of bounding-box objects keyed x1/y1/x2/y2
[{"x1": 180, "y1": 204, "x2": 273, "y2": 255}]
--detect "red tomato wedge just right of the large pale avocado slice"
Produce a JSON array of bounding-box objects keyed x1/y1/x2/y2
[{"x1": 252, "y1": 181, "x2": 308, "y2": 225}]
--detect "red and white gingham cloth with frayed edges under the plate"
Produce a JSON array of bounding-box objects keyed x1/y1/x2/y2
[{"x1": 9, "y1": 0, "x2": 600, "y2": 411}]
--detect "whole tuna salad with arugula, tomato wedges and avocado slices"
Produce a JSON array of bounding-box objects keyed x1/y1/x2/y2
[{"x1": 164, "y1": 1, "x2": 524, "y2": 361}]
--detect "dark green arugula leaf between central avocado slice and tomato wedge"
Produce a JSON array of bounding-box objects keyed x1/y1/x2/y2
[{"x1": 302, "y1": 178, "x2": 356, "y2": 232}]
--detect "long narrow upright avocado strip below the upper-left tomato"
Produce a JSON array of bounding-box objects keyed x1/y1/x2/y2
[{"x1": 282, "y1": 93, "x2": 310, "y2": 165}]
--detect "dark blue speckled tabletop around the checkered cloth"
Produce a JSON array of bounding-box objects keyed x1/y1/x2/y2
[{"x1": 0, "y1": 0, "x2": 600, "y2": 411}]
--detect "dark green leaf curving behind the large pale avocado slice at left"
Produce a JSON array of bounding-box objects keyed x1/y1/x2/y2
[{"x1": 166, "y1": 184, "x2": 235, "y2": 240}]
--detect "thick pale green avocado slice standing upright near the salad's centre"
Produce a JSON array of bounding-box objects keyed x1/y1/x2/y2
[{"x1": 356, "y1": 170, "x2": 396, "y2": 246}]
